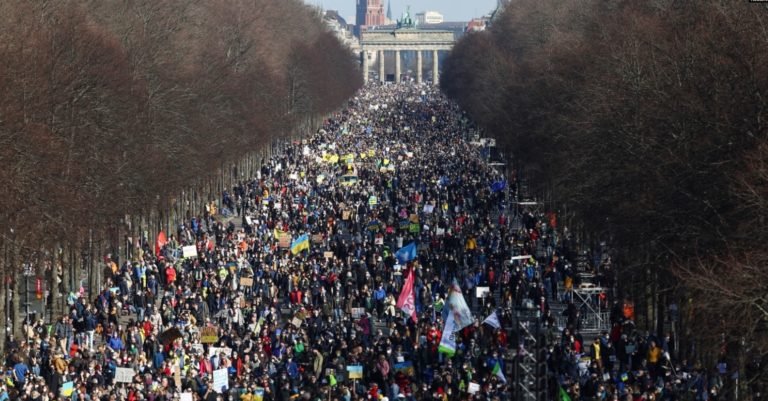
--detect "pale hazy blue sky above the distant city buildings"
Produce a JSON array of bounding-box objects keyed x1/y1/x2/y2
[{"x1": 304, "y1": 0, "x2": 496, "y2": 24}]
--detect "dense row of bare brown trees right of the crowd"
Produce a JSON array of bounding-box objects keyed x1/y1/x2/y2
[{"x1": 441, "y1": 0, "x2": 768, "y2": 394}]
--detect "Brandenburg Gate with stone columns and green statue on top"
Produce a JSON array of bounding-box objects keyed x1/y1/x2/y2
[{"x1": 360, "y1": 14, "x2": 455, "y2": 85}]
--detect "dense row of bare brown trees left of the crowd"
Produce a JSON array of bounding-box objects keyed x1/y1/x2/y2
[{"x1": 0, "y1": 0, "x2": 362, "y2": 344}]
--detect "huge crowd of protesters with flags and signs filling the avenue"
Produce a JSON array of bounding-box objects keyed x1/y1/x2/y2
[{"x1": 0, "y1": 85, "x2": 719, "y2": 401}]
